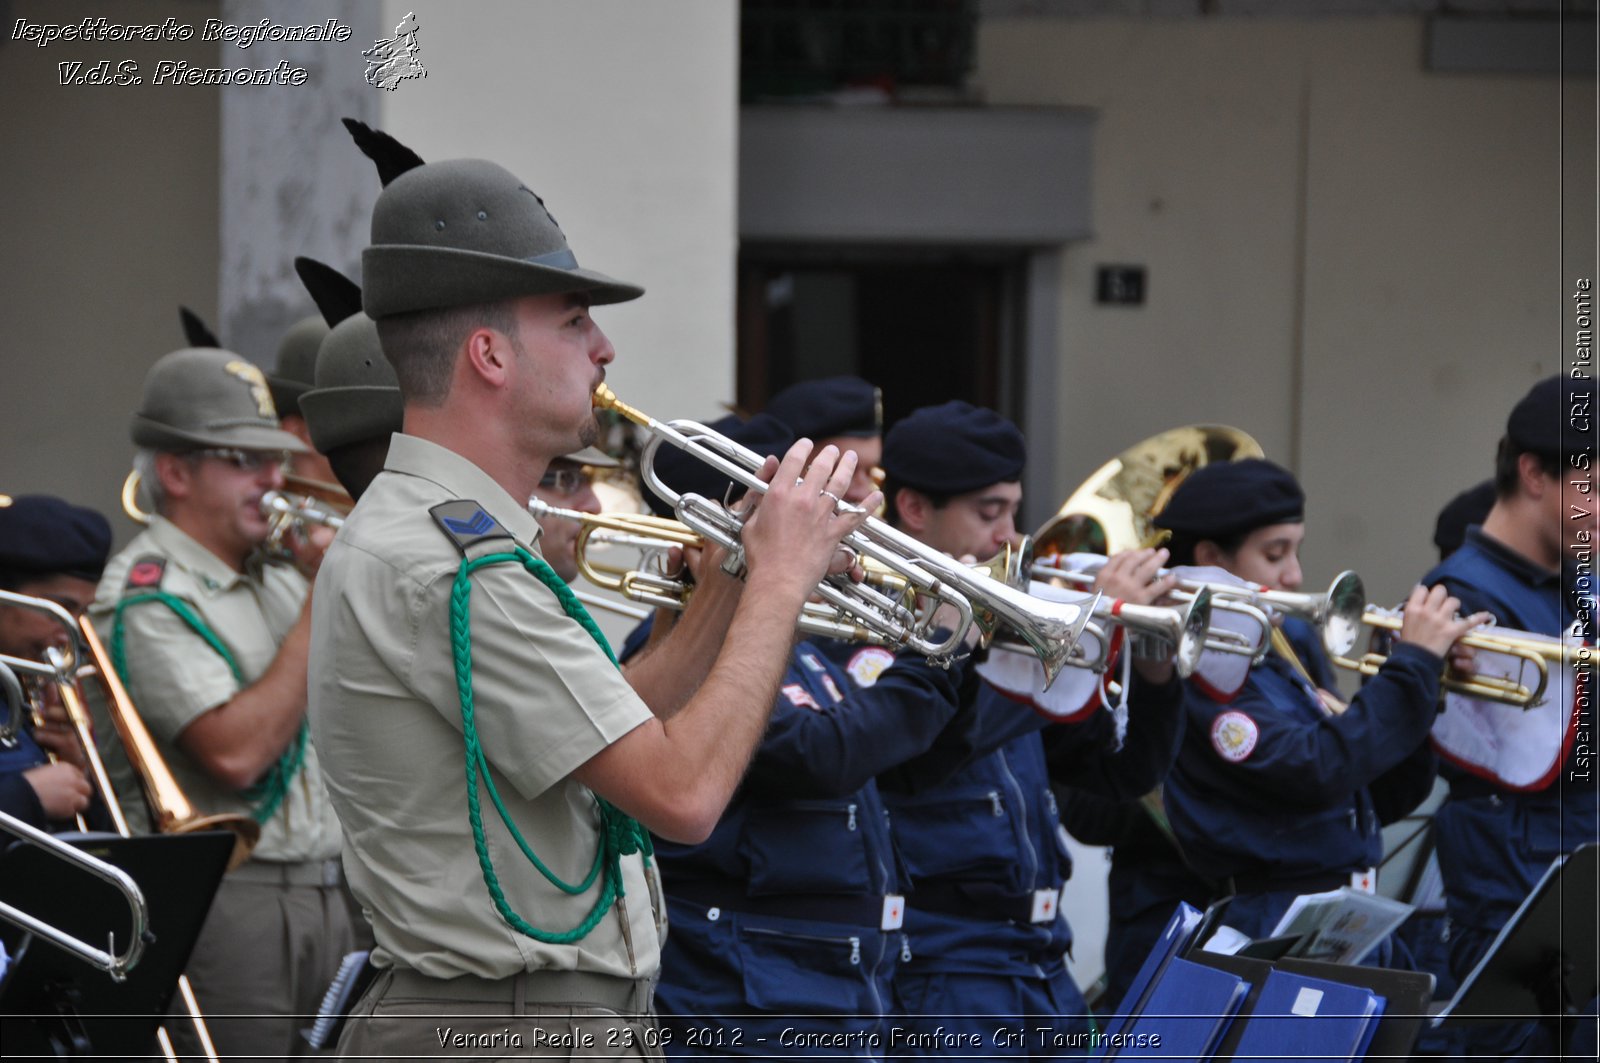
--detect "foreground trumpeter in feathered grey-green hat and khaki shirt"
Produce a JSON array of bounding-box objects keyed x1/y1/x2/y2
[{"x1": 310, "y1": 130, "x2": 861, "y2": 1057}]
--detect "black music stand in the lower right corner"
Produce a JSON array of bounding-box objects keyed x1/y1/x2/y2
[{"x1": 1434, "y1": 844, "x2": 1600, "y2": 1047}]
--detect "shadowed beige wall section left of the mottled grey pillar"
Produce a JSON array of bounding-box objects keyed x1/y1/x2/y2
[{"x1": 0, "y1": 0, "x2": 218, "y2": 541}]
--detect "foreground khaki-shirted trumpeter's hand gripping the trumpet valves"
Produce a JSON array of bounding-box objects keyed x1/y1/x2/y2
[{"x1": 741, "y1": 439, "x2": 880, "y2": 599}]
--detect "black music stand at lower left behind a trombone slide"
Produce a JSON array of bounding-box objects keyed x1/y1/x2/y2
[{"x1": 0, "y1": 831, "x2": 234, "y2": 1058}]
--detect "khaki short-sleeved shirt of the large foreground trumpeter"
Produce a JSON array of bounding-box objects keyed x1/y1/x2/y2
[{"x1": 310, "y1": 434, "x2": 659, "y2": 978}]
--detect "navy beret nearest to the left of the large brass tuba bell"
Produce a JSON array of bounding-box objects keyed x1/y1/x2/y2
[{"x1": 883, "y1": 399, "x2": 1027, "y2": 495}]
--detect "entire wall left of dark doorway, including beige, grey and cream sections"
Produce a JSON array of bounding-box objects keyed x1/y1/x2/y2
[{"x1": 0, "y1": 0, "x2": 738, "y2": 543}]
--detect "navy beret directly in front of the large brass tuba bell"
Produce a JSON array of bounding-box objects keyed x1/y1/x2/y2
[{"x1": 1154, "y1": 458, "x2": 1306, "y2": 540}]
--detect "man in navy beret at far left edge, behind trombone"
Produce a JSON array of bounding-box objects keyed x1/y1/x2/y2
[{"x1": 0, "y1": 495, "x2": 110, "y2": 829}]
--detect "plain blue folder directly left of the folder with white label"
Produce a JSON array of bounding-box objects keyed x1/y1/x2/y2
[{"x1": 1112, "y1": 959, "x2": 1250, "y2": 1063}]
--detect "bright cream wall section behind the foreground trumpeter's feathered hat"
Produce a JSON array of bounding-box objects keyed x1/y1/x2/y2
[{"x1": 382, "y1": 0, "x2": 739, "y2": 419}]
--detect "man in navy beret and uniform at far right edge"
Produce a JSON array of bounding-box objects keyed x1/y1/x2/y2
[{"x1": 1424, "y1": 375, "x2": 1600, "y2": 1055}]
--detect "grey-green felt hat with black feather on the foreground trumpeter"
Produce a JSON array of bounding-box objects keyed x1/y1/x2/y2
[{"x1": 344, "y1": 118, "x2": 645, "y2": 319}]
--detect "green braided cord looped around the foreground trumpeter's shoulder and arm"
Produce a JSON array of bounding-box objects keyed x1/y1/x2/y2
[{"x1": 450, "y1": 546, "x2": 651, "y2": 945}]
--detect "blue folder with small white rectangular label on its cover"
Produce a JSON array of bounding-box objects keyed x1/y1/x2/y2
[{"x1": 1234, "y1": 970, "x2": 1384, "y2": 1063}]
